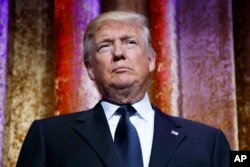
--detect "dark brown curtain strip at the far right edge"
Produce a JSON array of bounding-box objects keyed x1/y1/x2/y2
[{"x1": 233, "y1": 0, "x2": 250, "y2": 150}]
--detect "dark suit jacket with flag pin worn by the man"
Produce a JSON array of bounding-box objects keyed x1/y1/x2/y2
[{"x1": 17, "y1": 103, "x2": 230, "y2": 167}]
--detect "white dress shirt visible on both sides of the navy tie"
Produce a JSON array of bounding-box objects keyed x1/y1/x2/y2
[{"x1": 101, "y1": 94, "x2": 154, "y2": 167}]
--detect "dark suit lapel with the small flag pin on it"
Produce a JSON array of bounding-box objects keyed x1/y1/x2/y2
[{"x1": 149, "y1": 108, "x2": 186, "y2": 167}]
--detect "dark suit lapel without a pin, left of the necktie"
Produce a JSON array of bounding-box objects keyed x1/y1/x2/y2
[{"x1": 75, "y1": 102, "x2": 119, "y2": 167}]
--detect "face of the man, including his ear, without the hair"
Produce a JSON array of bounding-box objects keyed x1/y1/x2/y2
[{"x1": 88, "y1": 21, "x2": 155, "y2": 97}]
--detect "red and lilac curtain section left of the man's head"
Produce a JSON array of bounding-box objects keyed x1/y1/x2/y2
[{"x1": 54, "y1": 0, "x2": 100, "y2": 114}]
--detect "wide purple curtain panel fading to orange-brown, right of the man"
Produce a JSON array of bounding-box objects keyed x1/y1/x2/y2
[{"x1": 175, "y1": 0, "x2": 238, "y2": 149}]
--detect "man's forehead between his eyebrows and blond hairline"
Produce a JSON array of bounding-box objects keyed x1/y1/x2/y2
[{"x1": 94, "y1": 20, "x2": 141, "y2": 40}]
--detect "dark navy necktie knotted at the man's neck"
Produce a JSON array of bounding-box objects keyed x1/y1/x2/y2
[{"x1": 115, "y1": 105, "x2": 143, "y2": 167}]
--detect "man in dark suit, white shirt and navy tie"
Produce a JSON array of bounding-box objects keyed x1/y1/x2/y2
[{"x1": 17, "y1": 12, "x2": 230, "y2": 167}]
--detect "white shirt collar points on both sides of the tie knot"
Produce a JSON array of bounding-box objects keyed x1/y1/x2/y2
[{"x1": 101, "y1": 93, "x2": 154, "y2": 122}]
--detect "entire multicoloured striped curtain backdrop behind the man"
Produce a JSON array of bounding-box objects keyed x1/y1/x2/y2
[{"x1": 0, "y1": 0, "x2": 250, "y2": 167}]
